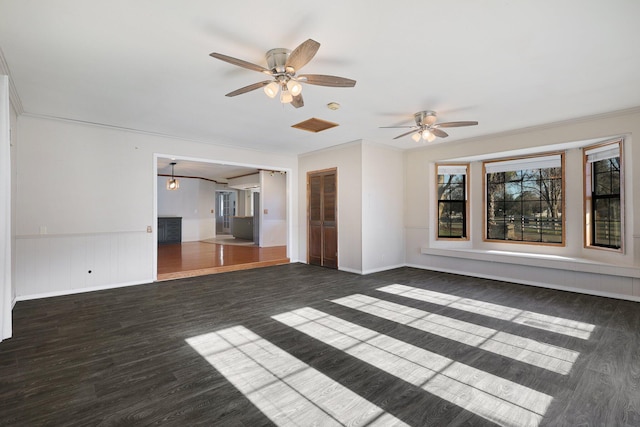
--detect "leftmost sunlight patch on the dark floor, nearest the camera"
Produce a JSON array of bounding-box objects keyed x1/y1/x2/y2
[{"x1": 186, "y1": 326, "x2": 406, "y2": 427}]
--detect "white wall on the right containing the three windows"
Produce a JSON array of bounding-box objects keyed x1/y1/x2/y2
[{"x1": 404, "y1": 109, "x2": 640, "y2": 299}]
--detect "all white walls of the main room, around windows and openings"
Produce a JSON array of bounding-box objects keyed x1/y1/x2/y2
[{"x1": 13, "y1": 110, "x2": 640, "y2": 306}]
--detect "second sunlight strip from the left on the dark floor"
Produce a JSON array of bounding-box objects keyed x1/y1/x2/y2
[{"x1": 273, "y1": 307, "x2": 553, "y2": 426}]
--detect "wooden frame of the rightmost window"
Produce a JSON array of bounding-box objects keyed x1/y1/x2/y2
[{"x1": 582, "y1": 138, "x2": 626, "y2": 253}]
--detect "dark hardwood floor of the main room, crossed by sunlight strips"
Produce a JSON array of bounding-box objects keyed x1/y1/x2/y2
[{"x1": 0, "y1": 264, "x2": 640, "y2": 427}]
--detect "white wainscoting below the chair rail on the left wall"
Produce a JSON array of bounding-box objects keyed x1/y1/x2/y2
[{"x1": 15, "y1": 232, "x2": 153, "y2": 299}]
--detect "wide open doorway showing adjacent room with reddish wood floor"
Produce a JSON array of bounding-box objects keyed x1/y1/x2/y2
[{"x1": 155, "y1": 156, "x2": 291, "y2": 280}]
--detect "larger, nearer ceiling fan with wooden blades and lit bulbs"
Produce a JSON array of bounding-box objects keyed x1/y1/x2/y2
[{"x1": 210, "y1": 39, "x2": 356, "y2": 108}]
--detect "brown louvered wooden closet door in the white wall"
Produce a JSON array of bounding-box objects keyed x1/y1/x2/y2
[{"x1": 307, "y1": 169, "x2": 338, "y2": 268}]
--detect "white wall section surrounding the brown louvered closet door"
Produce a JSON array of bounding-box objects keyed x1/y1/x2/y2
[{"x1": 298, "y1": 141, "x2": 362, "y2": 273}]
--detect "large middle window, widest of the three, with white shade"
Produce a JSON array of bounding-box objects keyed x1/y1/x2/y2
[{"x1": 484, "y1": 154, "x2": 564, "y2": 245}]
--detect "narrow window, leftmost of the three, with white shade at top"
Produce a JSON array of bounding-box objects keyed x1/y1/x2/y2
[{"x1": 437, "y1": 165, "x2": 467, "y2": 239}]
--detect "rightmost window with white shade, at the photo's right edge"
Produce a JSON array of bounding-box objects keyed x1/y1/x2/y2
[{"x1": 584, "y1": 141, "x2": 623, "y2": 249}]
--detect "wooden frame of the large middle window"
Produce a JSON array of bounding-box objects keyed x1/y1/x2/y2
[{"x1": 482, "y1": 151, "x2": 567, "y2": 247}]
